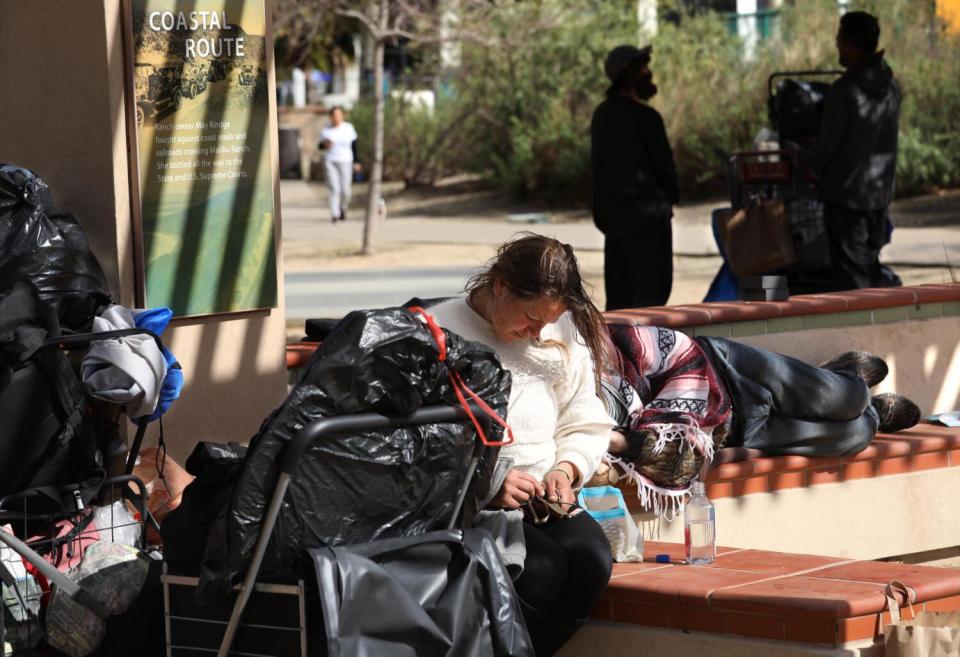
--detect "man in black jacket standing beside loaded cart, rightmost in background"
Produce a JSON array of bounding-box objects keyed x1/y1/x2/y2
[{"x1": 802, "y1": 11, "x2": 901, "y2": 290}]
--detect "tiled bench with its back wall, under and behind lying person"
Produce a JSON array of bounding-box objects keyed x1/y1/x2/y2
[{"x1": 605, "y1": 283, "x2": 960, "y2": 562}]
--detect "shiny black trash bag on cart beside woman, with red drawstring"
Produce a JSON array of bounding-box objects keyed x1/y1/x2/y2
[{"x1": 197, "y1": 308, "x2": 510, "y2": 601}]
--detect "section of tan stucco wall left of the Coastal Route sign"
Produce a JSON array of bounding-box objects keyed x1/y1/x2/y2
[{"x1": 0, "y1": 2, "x2": 133, "y2": 304}]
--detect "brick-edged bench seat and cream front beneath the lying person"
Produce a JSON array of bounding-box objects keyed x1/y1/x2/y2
[{"x1": 623, "y1": 424, "x2": 960, "y2": 564}]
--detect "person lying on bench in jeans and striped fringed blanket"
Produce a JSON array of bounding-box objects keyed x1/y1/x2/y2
[{"x1": 603, "y1": 324, "x2": 920, "y2": 510}]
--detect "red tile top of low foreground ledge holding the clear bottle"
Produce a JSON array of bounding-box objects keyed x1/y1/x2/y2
[{"x1": 593, "y1": 541, "x2": 960, "y2": 645}]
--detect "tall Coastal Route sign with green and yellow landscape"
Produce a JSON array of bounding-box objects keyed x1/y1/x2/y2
[{"x1": 129, "y1": 0, "x2": 277, "y2": 315}]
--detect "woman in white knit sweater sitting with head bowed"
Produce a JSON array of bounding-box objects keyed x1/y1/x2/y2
[{"x1": 429, "y1": 233, "x2": 613, "y2": 657}]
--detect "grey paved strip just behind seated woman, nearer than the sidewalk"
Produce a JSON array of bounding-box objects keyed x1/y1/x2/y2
[{"x1": 284, "y1": 267, "x2": 475, "y2": 318}]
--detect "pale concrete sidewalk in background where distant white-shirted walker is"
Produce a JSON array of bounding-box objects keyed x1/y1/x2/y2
[{"x1": 281, "y1": 181, "x2": 960, "y2": 266}]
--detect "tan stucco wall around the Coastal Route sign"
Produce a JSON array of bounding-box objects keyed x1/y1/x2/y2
[{"x1": 0, "y1": 0, "x2": 286, "y2": 460}]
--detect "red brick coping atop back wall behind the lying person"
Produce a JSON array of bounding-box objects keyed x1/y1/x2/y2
[{"x1": 604, "y1": 283, "x2": 960, "y2": 328}]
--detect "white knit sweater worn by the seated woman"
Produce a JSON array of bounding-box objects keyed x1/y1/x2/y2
[{"x1": 428, "y1": 297, "x2": 613, "y2": 483}]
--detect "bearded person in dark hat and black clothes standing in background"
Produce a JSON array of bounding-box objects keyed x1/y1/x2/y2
[{"x1": 590, "y1": 46, "x2": 679, "y2": 310}]
